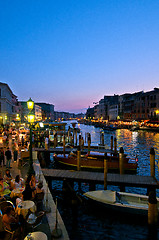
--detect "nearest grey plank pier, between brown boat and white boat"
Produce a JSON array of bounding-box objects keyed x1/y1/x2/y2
[{"x1": 42, "y1": 169, "x2": 159, "y2": 189}]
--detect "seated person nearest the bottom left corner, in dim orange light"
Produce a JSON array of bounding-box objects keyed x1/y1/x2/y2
[{"x1": 2, "y1": 206, "x2": 19, "y2": 231}]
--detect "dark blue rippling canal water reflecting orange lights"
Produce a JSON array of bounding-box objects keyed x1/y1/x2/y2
[{"x1": 52, "y1": 124, "x2": 159, "y2": 240}]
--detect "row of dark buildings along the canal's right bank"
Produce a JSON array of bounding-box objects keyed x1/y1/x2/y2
[{"x1": 86, "y1": 88, "x2": 159, "y2": 121}]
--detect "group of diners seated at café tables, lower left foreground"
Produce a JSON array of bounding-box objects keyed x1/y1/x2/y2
[{"x1": 0, "y1": 169, "x2": 44, "y2": 239}]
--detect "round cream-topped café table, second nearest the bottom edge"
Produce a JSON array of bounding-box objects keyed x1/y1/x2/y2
[{"x1": 16, "y1": 200, "x2": 36, "y2": 218}]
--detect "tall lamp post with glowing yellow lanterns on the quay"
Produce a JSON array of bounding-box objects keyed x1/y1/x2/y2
[{"x1": 27, "y1": 98, "x2": 35, "y2": 175}]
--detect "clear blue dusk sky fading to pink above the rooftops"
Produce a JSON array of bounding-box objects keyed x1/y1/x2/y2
[{"x1": 0, "y1": 0, "x2": 159, "y2": 113}]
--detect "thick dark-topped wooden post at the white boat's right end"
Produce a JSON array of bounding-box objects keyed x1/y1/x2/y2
[{"x1": 148, "y1": 191, "x2": 158, "y2": 226}]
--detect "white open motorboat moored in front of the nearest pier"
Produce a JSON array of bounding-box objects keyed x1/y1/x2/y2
[{"x1": 84, "y1": 190, "x2": 159, "y2": 215}]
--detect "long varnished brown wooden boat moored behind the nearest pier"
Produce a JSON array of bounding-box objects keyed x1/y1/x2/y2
[{"x1": 54, "y1": 151, "x2": 138, "y2": 173}]
